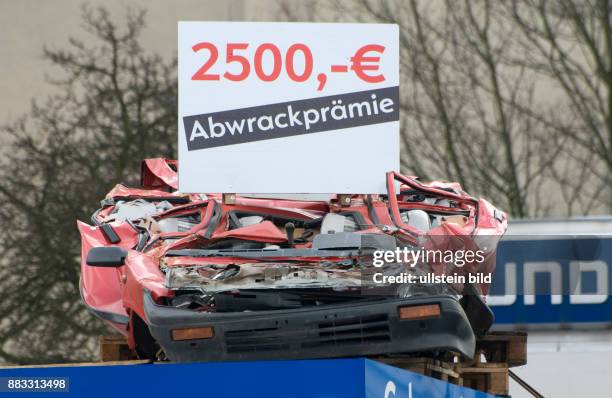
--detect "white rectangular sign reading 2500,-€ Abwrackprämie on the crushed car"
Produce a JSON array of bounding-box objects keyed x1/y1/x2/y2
[{"x1": 178, "y1": 22, "x2": 399, "y2": 193}]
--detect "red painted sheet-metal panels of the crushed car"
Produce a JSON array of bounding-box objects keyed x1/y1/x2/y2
[{"x1": 77, "y1": 158, "x2": 507, "y2": 347}]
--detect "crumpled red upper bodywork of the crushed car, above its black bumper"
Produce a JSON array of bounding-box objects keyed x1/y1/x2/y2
[{"x1": 78, "y1": 158, "x2": 507, "y2": 324}]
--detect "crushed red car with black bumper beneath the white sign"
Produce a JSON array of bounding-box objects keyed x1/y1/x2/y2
[{"x1": 77, "y1": 159, "x2": 507, "y2": 362}]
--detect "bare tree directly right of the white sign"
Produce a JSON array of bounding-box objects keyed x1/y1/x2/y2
[{"x1": 293, "y1": 0, "x2": 563, "y2": 217}]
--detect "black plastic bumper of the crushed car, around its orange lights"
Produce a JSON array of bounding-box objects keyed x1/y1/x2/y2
[{"x1": 144, "y1": 291, "x2": 475, "y2": 362}]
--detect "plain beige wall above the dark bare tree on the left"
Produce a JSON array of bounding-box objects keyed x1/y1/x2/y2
[{"x1": 0, "y1": 0, "x2": 277, "y2": 125}]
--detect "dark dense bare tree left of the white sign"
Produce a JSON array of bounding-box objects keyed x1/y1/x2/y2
[{"x1": 0, "y1": 8, "x2": 177, "y2": 364}]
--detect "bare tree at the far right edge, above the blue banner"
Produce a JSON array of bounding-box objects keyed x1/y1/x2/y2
[{"x1": 500, "y1": 0, "x2": 612, "y2": 210}]
